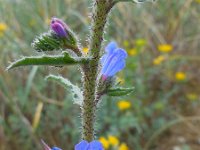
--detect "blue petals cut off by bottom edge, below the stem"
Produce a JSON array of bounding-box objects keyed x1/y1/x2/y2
[{"x1": 75, "y1": 140, "x2": 104, "y2": 150}]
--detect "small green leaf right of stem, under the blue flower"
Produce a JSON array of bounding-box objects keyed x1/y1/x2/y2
[{"x1": 107, "y1": 87, "x2": 134, "y2": 96}]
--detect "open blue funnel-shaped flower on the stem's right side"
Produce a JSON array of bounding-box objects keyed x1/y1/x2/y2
[{"x1": 101, "y1": 42, "x2": 127, "y2": 80}]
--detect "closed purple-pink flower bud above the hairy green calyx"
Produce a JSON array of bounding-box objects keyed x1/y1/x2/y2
[{"x1": 50, "y1": 18, "x2": 69, "y2": 38}]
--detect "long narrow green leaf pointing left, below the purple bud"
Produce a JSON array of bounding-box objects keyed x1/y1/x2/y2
[{"x1": 7, "y1": 52, "x2": 89, "y2": 70}]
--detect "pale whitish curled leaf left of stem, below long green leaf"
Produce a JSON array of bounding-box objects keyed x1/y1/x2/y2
[{"x1": 45, "y1": 75, "x2": 83, "y2": 106}]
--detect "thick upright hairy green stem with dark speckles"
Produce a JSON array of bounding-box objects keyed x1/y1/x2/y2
[{"x1": 82, "y1": 0, "x2": 112, "y2": 141}]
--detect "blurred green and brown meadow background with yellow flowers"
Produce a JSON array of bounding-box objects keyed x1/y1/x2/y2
[{"x1": 0, "y1": 0, "x2": 200, "y2": 150}]
